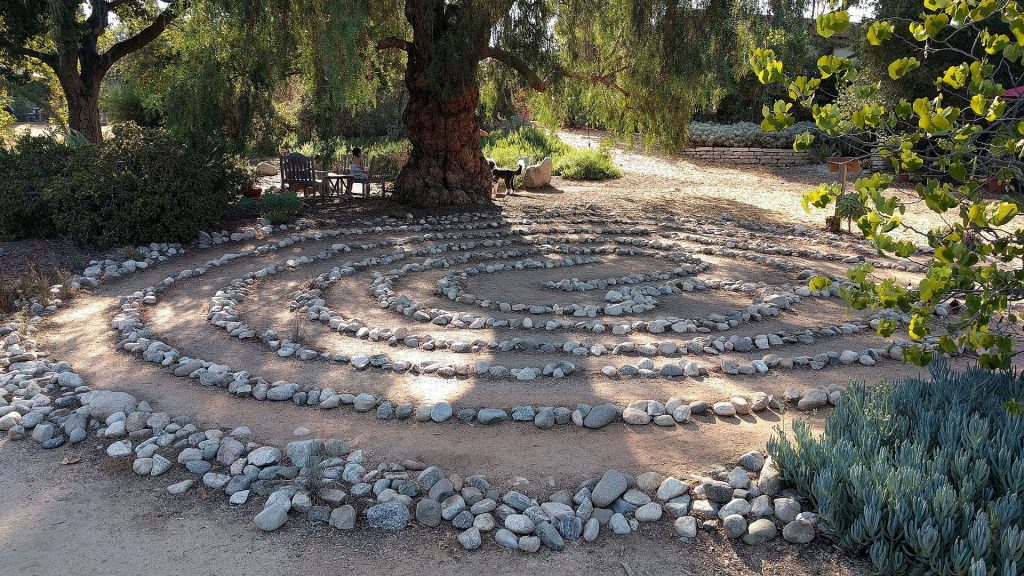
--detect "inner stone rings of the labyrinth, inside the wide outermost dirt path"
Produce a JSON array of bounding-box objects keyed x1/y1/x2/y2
[{"x1": 110, "y1": 204, "x2": 917, "y2": 422}]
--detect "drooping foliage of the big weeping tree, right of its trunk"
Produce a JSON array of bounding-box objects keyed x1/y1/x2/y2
[{"x1": 528, "y1": 0, "x2": 756, "y2": 150}]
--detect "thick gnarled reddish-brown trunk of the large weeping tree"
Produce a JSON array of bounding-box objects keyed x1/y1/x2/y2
[{"x1": 395, "y1": 0, "x2": 490, "y2": 207}]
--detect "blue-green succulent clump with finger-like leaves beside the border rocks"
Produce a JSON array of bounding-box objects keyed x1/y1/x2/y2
[{"x1": 768, "y1": 364, "x2": 1024, "y2": 576}]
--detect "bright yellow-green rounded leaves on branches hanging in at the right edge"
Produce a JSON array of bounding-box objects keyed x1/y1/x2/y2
[{"x1": 751, "y1": 0, "x2": 1024, "y2": 370}]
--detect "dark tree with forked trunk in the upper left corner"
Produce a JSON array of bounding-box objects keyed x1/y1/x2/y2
[{"x1": 0, "y1": 0, "x2": 180, "y2": 142}]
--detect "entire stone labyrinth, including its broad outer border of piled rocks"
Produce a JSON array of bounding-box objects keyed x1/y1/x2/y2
[{"x1": 6, "y1": 205, "x2": 937, "y2": 550}]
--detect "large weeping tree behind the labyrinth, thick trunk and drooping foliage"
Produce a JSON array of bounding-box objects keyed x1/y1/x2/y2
[{"x1": 226, "y1": 0, "x2": 749, "y2": 207}]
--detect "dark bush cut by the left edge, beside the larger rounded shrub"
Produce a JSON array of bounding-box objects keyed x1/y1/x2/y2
[{"x1": 0, "y1": 135, "x2": 72, "y2": 240}]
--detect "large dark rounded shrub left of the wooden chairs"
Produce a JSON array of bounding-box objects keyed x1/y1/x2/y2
[{"x1": 46, "y1": 124, "x2": 249, "y2": 248}]
